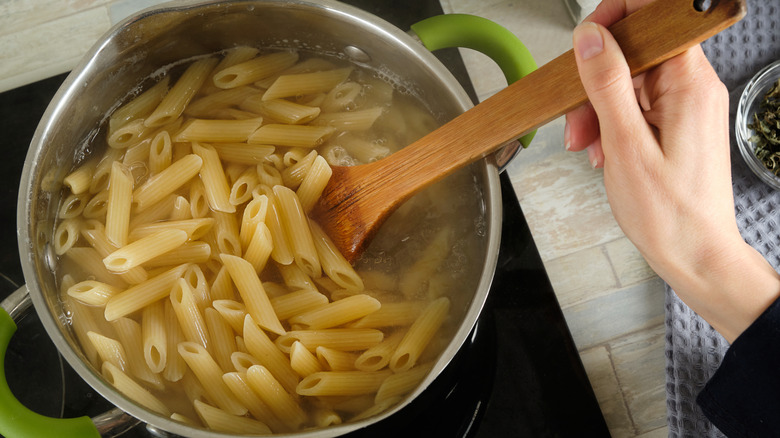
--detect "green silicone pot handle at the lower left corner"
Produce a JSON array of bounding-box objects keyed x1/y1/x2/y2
[{"x1": 0, "y1": 308, "x2": 100, "y2": 438}]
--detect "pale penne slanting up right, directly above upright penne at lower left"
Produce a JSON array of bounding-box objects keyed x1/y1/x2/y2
[{"x1": 105, "y1": 264, "x2": 188, "y2": 321}]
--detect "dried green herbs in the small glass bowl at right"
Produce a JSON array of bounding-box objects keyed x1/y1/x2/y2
[{"x1": 748, "y1": 78, "x2": 780, "y2": 176}]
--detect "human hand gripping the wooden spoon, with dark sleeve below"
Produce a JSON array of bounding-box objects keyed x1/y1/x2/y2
[{"x1": 565, "y1": 0, "x2": 780, "y2": 341}]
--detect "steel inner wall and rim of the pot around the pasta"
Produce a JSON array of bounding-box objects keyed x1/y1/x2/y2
[{"x1": 18, "y1": 1, "x2": 500, "y2": 436}]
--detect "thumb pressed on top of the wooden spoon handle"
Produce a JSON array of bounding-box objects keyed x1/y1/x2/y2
[{"x1": 573, "y1": 22, "x2": 647, "y2": 149}]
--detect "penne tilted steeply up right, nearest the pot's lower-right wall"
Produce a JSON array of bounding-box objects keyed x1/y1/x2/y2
[{"x1": 389, "y1": 297, "x2": 450, "y2": 372}]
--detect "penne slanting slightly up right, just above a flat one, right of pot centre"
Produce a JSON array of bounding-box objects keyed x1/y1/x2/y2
[{"x1": 290, "y1": 294, "x2": 382, "y2": 330}]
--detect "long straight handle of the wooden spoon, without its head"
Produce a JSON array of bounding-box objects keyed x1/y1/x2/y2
[{"x1": 372, "y1": 0, "x2": 746, "y2": 192}]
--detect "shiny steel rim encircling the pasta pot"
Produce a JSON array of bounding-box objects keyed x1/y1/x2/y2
[{"x1": 17, "y1": 0, "x2": 502, "y2": 438}]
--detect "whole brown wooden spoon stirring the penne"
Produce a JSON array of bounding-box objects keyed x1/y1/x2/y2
[{"x1": 312, "y1": 0, "x2": 746, "y2": 261}]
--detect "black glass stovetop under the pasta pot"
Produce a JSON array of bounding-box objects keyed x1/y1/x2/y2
[{"x1": 0, "y1": 0, "x2": 609, "y2": 438}]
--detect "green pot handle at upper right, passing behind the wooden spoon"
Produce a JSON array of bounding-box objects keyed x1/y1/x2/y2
[{"x1": 411, "y1": 14, "x2": 536, "y2": 147}]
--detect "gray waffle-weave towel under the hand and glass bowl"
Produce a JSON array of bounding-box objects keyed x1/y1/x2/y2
[{"x1": 666, "y1": 0, "x2": 780, "y2": 438}]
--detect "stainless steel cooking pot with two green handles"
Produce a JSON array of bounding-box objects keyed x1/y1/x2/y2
[{"x1": 0, "y1": 0, "x2": 535, "y2": 437}]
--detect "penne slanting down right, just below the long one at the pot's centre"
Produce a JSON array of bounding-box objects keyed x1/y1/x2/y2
[{"x1": 244, "y1": 315, "x2": 298, "y2": 393}]
